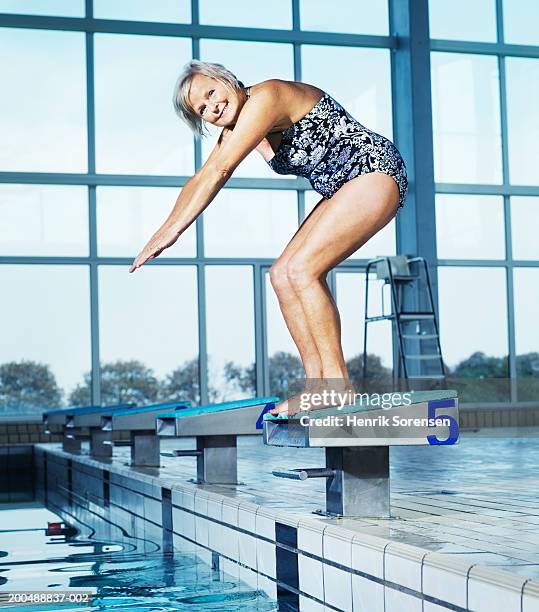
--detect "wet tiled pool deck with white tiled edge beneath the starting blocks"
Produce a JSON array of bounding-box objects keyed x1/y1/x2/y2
[{"x1": 34, "y1": 430, "x2": 539, "y2": 612}]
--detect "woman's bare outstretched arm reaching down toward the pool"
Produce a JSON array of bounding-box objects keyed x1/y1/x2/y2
[{"x1": 129, "y1": 81, "x2": 284, "y2": 272}]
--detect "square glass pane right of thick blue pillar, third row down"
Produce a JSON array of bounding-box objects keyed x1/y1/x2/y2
[{"x1": 436, "y1": 194, "x2": 505, "y2": 259}]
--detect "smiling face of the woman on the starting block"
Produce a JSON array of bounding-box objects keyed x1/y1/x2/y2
[{"x1": 189, "y1": 74, "x2": 245, "y2": 127}]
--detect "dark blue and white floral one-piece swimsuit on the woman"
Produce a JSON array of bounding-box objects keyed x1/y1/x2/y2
[{"x1": 268, "y1": 94, "x2": 408, "y2": 210}]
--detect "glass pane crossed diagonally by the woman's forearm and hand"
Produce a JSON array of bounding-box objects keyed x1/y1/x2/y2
[{"x1": 97, "y1": 187, "x2": 196, "y2": 257}]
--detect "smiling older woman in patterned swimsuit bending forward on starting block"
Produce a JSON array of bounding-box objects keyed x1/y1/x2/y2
[{"x1": 130, "y1": 60, "x2": 407, "y2": 414}]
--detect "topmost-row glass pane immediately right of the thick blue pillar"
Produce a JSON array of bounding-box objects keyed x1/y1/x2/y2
[{"x1": 429, "y1": 0, "x2": 496, "y2": 42}]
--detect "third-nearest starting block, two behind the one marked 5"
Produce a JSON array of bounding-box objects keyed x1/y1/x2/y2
[{"x1": 100, "y1": 400, "x2": 192, "y2": 467}]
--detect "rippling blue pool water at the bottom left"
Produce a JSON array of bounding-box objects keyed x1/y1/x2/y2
[{"x1": 0, "y1": 504, "x2": 286, "y2": 612}]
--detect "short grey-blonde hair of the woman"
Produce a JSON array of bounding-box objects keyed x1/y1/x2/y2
[{"x1": 172, "y1": 60, "x2": 244, "y2": 136}]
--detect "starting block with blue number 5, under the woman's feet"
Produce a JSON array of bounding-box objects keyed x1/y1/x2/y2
[{"x1": 263, "y1": 390, "x2": 459, "y2": 518}]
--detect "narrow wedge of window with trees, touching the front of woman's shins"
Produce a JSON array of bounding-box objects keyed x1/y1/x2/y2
[{"x1": 264, "y1": 272, "x2": 305, "y2": 399}]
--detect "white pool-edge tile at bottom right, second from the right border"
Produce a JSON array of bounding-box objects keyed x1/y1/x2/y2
[{"x1": 468, "y1": 565, "x2": 526, "y2": 612}]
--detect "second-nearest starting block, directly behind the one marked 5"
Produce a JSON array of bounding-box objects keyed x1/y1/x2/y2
[{"x1": 156, "y1": 397, "x2": 279, "y2": 484}]
